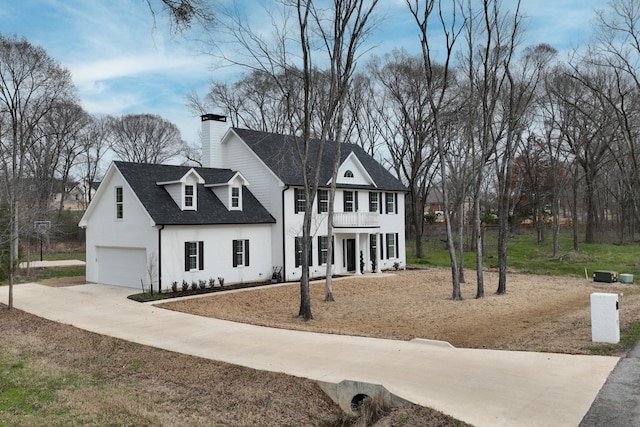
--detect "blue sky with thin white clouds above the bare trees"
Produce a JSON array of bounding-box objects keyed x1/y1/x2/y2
[{"x1": 0, "y1": 0, "x2": 605, "y2": 147}]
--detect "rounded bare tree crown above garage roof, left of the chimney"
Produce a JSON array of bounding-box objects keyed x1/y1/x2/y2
[{"x1": 109, "y1": 114, "x2": 184, "y2": 164}]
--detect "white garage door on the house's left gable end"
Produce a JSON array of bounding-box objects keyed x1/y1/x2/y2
[{"x1": 96, "y1": 246, "x2": 149, "y2": 289}]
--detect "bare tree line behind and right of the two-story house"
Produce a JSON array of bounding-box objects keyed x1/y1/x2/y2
[{"x1": 189, "y1": 0, "x2": 640, "y2": 299}]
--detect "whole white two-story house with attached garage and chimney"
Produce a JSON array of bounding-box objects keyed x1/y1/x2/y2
[{"x1": 80, "y1": 114, "x2": 406, "y2": 289}]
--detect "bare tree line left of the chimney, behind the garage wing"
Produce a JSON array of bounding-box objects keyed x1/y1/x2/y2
[{"x1": 0, "y1": 35, "x2": 188, "y2": 306}]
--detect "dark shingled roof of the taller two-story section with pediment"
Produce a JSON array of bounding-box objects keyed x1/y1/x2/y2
[{"x1": 233, "y1": 128, "x2": 407, "y2": 191}]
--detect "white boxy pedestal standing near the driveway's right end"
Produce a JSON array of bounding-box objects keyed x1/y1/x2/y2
[{"x1": 591, "y1": 292, "x2": 620, "y2": 344}]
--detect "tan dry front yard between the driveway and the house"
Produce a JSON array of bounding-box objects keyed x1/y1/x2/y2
[{"x1": 162, "y1": 269, "x2": 640, "y2": 354}]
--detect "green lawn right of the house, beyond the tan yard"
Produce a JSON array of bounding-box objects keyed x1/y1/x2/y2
[{"x1": 407, "y1": 233, "x2": 640, "y2": 277}]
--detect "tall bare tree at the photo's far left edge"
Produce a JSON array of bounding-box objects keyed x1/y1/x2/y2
[{"x1": 0, "y1": 36, "x2": 74, "y2": 308}]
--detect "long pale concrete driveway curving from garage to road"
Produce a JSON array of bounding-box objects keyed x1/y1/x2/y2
[{"x1": 0, "y1": 284, "x2": 619, "y2": 427}]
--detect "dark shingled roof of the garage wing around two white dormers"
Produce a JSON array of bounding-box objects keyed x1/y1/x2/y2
[{"x1": 114, "y1": 161, "x2": 275, "y2": 225}]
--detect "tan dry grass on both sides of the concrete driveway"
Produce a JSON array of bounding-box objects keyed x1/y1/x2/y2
[{"x1": 6, "y1": 269, "x2": 640, "y2": 427}]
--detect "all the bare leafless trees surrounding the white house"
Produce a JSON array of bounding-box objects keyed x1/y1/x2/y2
[{"x1": 5, "y1": 0, "x2": 640, "y2": 308}]
